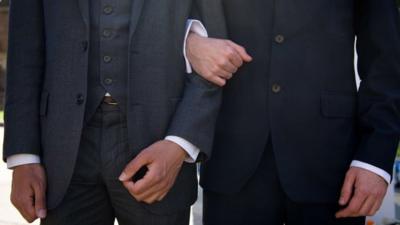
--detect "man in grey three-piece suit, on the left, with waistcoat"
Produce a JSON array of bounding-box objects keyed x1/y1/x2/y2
[{"x1": 4, "y1": 0, "x2": 220, "y2": 225}]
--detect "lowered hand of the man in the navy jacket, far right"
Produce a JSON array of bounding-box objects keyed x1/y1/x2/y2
[{"x1": 336, "y1": 167, "x2": 388, "y2": 218}]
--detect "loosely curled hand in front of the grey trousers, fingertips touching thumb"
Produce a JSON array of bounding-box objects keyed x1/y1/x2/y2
[{"x1": 120, "y1": 140, "x2": 187, "y2": 204}]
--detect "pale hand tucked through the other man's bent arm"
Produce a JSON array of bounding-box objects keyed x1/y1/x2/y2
[{"x1": 186, "y1": 33, "x2": 252, "y2": 87}]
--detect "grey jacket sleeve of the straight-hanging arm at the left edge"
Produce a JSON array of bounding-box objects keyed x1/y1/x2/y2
[{"x1": 3, "y1": 0, "x2": 44, "y2": 160}]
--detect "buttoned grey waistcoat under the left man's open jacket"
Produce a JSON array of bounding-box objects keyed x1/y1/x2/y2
[{"x1": 85, "y1": 0, "x2": 132, "y2": 121}]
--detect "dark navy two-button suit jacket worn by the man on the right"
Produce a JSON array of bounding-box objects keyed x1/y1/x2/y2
[{"x1": 198, "y1": 0, "x2": 400, "y2": 224}]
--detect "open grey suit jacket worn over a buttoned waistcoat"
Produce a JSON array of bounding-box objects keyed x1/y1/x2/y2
[{"x1": 3, "y1": 0, "x2": 221, "y2": 213}]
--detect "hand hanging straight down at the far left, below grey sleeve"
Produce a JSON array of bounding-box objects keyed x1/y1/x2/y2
[{"x1": 11, "y1": 164, "x2": 47, "y2": 223}]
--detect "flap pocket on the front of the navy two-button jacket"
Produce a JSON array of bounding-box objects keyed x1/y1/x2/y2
[{"x1": 321, "y1": 93, "x2": 357, "y2": 118}]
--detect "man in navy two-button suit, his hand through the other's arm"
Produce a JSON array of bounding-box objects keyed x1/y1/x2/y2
[{"x1": 187, "y1": 0, "x2": 400, "y2": 225}]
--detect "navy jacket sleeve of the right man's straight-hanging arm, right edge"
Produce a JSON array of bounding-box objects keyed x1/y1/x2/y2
[{"x1": 355, "y1": 0, "x2": 400, "y2": 174}]
